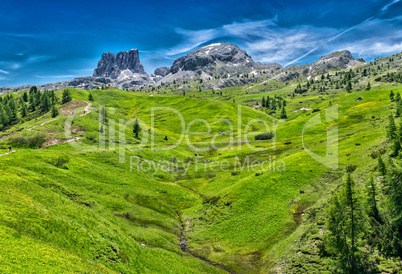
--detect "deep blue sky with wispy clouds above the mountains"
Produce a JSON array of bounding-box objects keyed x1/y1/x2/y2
[{"x1": 0, "y1": 0, "x2": 402, "y2": 87}]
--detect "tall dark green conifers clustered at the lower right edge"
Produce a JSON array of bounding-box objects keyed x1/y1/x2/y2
[{"x1": 321, "y1": 92, "x2": 402, "y2": 273}]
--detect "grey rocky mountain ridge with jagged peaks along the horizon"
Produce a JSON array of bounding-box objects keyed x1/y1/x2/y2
[{"x1": 0, "y1": 42, "x2": 364, "y2": 93}]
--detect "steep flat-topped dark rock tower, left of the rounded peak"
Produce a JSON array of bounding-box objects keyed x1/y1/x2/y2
[{"x1": 93, "y1": 49, "x2": 145, "y2": 79}]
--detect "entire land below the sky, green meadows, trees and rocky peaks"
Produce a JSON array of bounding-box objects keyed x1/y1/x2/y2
[{"x1": 0, "y1": 42, "x2": 402, "y2": 273}]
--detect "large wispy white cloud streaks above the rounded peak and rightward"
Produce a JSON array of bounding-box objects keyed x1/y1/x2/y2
[{"x1": 166, "y1": 12, "x2": 402, "y2": 65}]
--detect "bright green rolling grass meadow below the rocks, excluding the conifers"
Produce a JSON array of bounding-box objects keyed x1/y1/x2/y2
[{"x1": 0, "y1": 54, "x2": 402, "y2": 273}]
